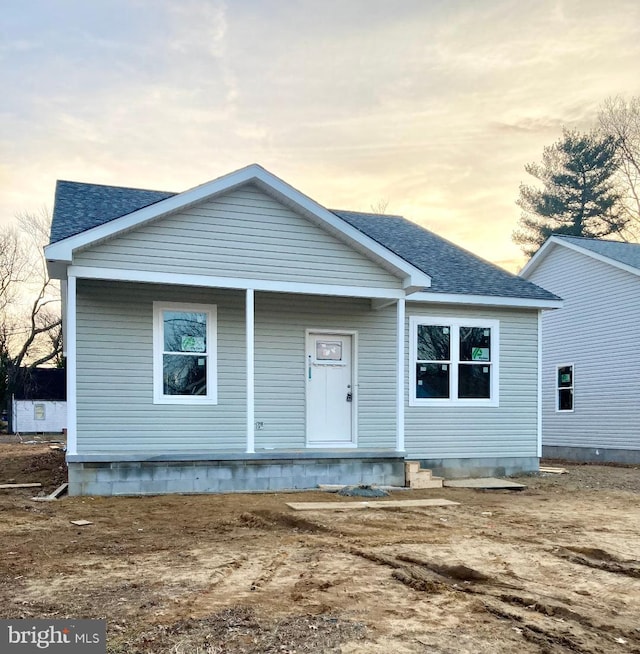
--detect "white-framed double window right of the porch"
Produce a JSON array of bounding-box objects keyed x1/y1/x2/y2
[{"x1": 409, "y1": 316, "x2": 499, "y2": 406}]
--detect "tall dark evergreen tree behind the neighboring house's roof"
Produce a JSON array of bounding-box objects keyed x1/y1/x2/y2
[{"x1": 513, "y1": 129, "x2": 629, "y2": 256}]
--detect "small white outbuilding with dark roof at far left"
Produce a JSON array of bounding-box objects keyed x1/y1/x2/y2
[{"x1": 11, "y1": 368, "x2": 67, "y2": 434}]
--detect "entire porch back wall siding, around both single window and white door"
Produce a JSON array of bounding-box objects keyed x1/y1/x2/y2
[{"x1": 77, "y1": 280, "x2": 396, "y2": 455}]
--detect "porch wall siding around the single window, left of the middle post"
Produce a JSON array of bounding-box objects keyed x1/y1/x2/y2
[{"x1": 77, "y1": 280, "x2": 246, "y2": 453}]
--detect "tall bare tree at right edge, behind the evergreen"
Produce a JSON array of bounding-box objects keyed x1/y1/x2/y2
[{"x1": 598, "y1": 96, "x2": 640, "y2": 240}]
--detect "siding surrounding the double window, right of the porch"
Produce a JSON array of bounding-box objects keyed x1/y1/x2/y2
[{"x1": 405, "y1": 303, "x2": 538, "y2": 459}]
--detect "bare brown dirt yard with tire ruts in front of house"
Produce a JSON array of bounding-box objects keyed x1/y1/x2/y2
[{"x1": 0, "y1": 444, "x2": 640, "y2": 654}]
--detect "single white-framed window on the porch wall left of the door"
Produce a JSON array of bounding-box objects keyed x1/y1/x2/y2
[{"x1": 153, "y1": 302, "x2": 217, "y2": 404}]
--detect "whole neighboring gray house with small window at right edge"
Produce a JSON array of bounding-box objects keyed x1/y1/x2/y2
[{"x1": 520, "y1": 236, "x2": 640, "y2": 463}]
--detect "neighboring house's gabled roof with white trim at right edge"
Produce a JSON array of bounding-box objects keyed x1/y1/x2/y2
[{"x1": 520, "y1": 234, "x2": 640, "y2": 279}]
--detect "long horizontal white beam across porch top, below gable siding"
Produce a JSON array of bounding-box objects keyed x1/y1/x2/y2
[{"x1": 69, "y1": 266, "x2": 405, "y2": 300}]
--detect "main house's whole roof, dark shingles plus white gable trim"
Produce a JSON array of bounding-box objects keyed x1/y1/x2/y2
[{"x1": 47, "y1": 164, "x2": 559, "y2": 303}]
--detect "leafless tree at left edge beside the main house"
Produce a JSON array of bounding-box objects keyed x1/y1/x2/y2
[{"x1": 0, "y1": 211, "x2": 62, "y2": 430}]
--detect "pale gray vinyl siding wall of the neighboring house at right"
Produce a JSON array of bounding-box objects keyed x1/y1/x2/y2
[{"x1": 530, "y1": 246, "x2": 640, "y2": 450}]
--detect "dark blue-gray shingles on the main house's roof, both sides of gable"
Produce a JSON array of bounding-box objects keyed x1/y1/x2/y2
[{"x1": 51, "y1": 181, "x2": 559, "y2": 300}]
